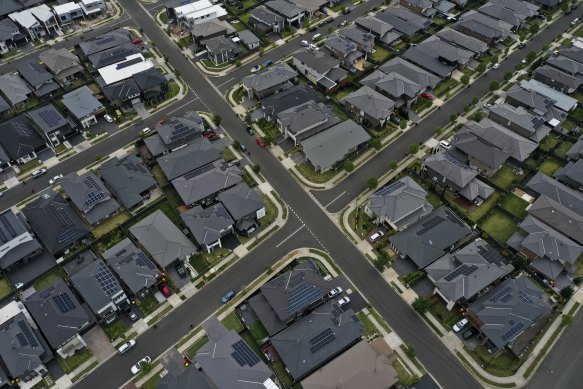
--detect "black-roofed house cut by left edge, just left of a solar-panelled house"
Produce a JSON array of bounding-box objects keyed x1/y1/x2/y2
[{"x1": 0, "y1": 113, "x2": 47, "y2": 164}]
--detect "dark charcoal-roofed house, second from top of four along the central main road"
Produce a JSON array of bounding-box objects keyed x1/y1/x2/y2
[{"x1": 261, "y1": 84, "x2": 322, "y2": 121}]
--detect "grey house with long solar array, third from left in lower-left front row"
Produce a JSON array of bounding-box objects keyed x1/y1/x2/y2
[{"x1": 70, "y1": 253, "x2": 131, "y2": 324}]
